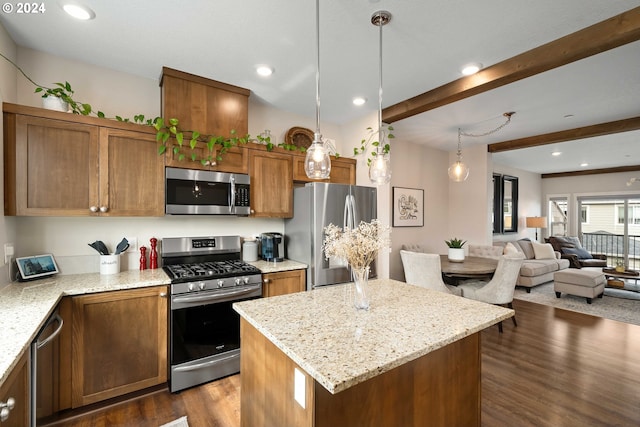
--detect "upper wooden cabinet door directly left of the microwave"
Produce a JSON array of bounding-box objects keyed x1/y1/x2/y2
[{"x1": 100, "y1": 128, "x2": 164, "y2": 216}]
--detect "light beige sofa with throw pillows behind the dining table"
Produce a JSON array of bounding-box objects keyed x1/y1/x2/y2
[{"x1": 469, "y1": 239, "x2": 569, "y2": 292}]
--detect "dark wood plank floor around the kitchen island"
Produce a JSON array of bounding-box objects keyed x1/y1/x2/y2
[{"x1": 52, "y1": 300, "x2": 640, "y2": 427}]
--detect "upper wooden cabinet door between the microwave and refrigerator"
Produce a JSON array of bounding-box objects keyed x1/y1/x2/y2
[{"x1": 249, "y1": 150, "x2": 293, "y2": 218}]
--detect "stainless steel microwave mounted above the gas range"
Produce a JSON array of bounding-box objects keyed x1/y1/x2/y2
[{"x1": 165, "y1": 168, "x2": 251, "y2": 216}]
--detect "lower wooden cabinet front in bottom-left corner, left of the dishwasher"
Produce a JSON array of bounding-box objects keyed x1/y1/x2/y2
[{"x1": 0, "y1": 352, "x2": 29, "y2": 427}]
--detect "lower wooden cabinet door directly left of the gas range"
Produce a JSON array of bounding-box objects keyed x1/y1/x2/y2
[{"x1": 72, "y1": 286, "x2": 167, "y2": 408}]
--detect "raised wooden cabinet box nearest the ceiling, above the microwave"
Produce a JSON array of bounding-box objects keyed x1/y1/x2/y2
[{"x1": 160, "y1": 67, "x2": 251, "y2": 137}]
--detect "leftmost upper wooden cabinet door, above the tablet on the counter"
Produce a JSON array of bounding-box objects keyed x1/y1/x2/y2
[{"x1": 5, "y1": 115, "x2": 99, "y2": 216}]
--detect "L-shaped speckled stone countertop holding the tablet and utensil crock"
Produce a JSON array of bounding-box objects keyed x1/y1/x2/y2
[{"x1": 0, "y1": 269, "x2": 170, "y2": 386}]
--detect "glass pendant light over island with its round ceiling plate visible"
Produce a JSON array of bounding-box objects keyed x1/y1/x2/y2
[{"x1": 369, "y1": 10, "x2": 391, "y2": 185}]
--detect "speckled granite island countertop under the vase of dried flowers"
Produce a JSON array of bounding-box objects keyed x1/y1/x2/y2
[{"x1": 233, "y1": 279, "x2": 514, "y2": 394}]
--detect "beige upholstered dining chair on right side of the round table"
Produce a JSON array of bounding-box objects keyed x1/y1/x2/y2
[{"x1": 459, "y1": 254, "x2": 524, "y2": 333}]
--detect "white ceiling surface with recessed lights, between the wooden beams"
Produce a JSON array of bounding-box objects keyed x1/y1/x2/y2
[{"x1": 0, "y1": 0, "x2": 640, "y2": 173}]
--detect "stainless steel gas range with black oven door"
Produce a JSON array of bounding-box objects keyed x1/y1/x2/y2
[{"x1": 162, "y1": 236, "x2": 262, "y2": 392}]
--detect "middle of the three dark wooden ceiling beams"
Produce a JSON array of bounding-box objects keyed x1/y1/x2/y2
[{"x1": 487, "y1": 117, "x2": 640, "y2": 153}]
